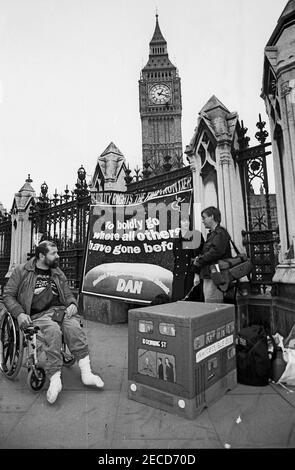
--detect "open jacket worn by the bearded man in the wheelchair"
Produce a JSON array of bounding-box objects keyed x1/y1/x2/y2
[{"x1": 3, "y1": 258, "x2": 77, "y2": 318}]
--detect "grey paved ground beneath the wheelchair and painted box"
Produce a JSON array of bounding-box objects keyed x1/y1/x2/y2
[{"x1": 0, "y1": 310, "x2": 295, "y2": 449}]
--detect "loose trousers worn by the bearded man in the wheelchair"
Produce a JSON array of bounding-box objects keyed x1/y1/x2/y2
[{"x1": 32, "y1": 307, "x2": 89, "y2": 378}]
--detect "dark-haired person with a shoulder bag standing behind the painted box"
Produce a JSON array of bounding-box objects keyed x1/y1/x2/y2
[{"x1": 192, "y1": 206, "x2": 232, "y2": 303}]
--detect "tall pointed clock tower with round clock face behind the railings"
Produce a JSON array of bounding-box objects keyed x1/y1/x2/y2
[{"x1": 139, "y1": 15, "x2": 183, "y2": 176}]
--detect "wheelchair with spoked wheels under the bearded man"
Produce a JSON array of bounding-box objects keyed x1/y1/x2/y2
[{"x1": 0, "y1": 311, "x2": 75, "y2": 392}]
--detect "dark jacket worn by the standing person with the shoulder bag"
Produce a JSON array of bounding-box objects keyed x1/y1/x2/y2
[{"x1": 193, "y1": 225, "x2": 232, "y2": 279}]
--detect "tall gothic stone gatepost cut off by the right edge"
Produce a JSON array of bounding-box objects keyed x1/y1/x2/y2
[{"x1": 262, "y1": 0, "x2": 295, "y2": 336}]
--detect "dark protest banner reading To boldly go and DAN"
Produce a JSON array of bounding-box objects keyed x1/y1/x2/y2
[{"x1": 82, "y1": 176, "x2": 192, "y2": 304}]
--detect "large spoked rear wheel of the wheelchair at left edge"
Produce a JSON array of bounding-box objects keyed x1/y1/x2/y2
[{"x1": 0, "y1": 312, "x2": 24, "y2": 380}]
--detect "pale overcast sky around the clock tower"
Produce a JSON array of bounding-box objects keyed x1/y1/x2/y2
[{"x1": 0, "y1": 0, "x2": 287, "y2": 210}]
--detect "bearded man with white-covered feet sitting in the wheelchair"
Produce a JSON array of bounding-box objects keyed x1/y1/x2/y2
[{"x1": 3, "y1": 241, "x2": 104, "y2": 404}]
